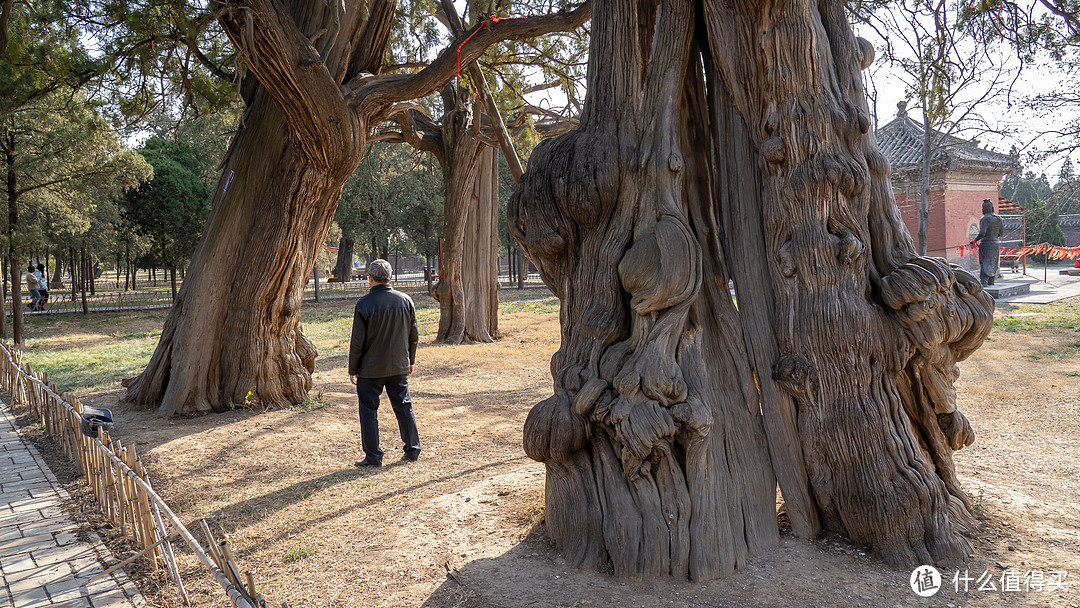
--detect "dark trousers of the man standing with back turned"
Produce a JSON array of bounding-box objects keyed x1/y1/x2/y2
[{"x1": 356, "y1": 374, "x2": 420, "y2": 464}]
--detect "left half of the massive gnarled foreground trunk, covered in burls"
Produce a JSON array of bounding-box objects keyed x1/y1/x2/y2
[{"x1": 510, "y1": 0, "x2": 778, "y2": 579}]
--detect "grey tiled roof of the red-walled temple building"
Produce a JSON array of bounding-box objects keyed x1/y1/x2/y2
[{"x1": 876, "y1": 109, "x2": 1016, "y2": 173}]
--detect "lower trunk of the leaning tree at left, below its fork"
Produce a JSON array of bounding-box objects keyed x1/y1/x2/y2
[{"x1": 127, "y1": 90, "x2": 362, "y2": 415}]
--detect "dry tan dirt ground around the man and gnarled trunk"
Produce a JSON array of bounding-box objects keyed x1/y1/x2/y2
[{"x1": 23, "y1": 301, "x2": 1080, "y2": 608}]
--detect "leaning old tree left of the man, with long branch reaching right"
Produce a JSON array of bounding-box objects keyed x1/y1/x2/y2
[{"x1": 125, "y1": 0, "x2": 589, "y2": 415}]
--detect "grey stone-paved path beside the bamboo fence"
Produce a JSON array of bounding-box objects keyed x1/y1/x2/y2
[{"x1": 0, "y1": 403, "x2": 146, "y2": 608}]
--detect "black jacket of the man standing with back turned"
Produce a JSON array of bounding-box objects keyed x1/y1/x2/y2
[{"x1": 349, "y1": 284, "x2": 419, "y2": 378}]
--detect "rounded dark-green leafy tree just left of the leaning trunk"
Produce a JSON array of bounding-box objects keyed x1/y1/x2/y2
[{"x1": 121, "y1": 137, "x2": 211, "y2": 268}]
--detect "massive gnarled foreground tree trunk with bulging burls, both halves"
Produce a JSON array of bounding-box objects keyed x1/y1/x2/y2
[{"x1": 510, "y1": 0, "x2": 993, "y2": 580}]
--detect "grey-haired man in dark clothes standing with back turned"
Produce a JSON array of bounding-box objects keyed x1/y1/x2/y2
[{"x1": 349, "y1": 259, "x2": 420, "y2": 468}]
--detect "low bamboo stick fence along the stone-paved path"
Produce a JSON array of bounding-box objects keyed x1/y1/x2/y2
[{"x1": 0, "y1": 341, "x2": 286, "y2": 608}]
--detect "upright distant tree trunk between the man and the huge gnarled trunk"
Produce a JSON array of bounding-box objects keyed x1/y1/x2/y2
[{"x1": 435, "y1": 87, "x2": 499, "y2": 344}]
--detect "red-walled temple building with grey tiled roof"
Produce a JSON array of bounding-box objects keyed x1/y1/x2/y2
[{"x1": 876, "y1": 102, "x2": 1018, "y2": 269}]
